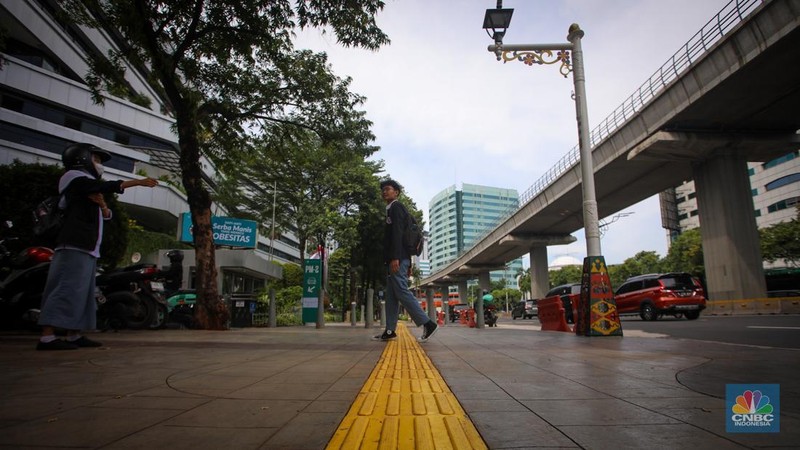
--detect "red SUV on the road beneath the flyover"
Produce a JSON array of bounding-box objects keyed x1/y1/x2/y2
[{"x1": 614, "y1": 273, "x2": 706, "y2": 320}]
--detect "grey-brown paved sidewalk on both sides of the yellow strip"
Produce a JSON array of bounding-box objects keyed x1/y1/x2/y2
[{"x1": 0, "y1": 323, "x2": 800, "y2": 450}]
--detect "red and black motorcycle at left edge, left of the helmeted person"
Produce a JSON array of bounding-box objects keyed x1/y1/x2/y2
[{"x1": 0, "y1": 221, "x2": 53, "y2": 328}]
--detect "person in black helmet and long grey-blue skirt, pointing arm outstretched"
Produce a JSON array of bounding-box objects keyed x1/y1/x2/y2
[{"x1": 36, "y1": 144, "x2": 158, "y2": 350}]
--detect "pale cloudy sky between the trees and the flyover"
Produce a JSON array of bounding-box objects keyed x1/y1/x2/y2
[{"x1": 296, "y1": 0, "x2": 728, "y2": 267}]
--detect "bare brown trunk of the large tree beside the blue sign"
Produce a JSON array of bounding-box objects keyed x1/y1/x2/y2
[{"x1": 176, "y1": 108, "x2": 225, "y2": 330}]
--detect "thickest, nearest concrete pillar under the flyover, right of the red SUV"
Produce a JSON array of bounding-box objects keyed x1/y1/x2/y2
[{"x1": 692, "y1": 154, "x2": 767, "y2": 300}]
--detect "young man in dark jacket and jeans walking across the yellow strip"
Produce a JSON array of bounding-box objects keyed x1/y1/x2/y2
[{"x1": 372, "y1": 180, "x2": 439, "y2": 342}]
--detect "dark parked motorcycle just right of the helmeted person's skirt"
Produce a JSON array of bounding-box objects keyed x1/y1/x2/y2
[{"x1": 95, "y1": 264, "x2": 167, "y2": 330}]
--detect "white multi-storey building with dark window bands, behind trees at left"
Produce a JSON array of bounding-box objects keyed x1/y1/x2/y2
[{"x1": 0, "y1": 0, "x2": 300, "y2": 292}]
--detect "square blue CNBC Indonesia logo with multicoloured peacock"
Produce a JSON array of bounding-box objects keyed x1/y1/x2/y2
[{"x1": 725, "y1": 384, "x2": 780, "y2": 433}]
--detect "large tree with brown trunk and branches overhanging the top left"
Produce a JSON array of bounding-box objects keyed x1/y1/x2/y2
[{"x1": 62, "y1": 0, "x2": 389, "y2": 329}]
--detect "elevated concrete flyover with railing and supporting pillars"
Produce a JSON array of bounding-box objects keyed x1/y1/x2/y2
[{"x1": 421, "y1": 0, "x2": 800, "y2": 300}]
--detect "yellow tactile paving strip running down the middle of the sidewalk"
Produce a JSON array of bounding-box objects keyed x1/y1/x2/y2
[{"x1": 327, "y1": 323, "x2": 487, "y2": 450}]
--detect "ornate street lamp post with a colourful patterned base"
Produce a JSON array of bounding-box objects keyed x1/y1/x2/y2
[{"x1": 483, "y1": 0, "x2": 622, "y2": 336}]
